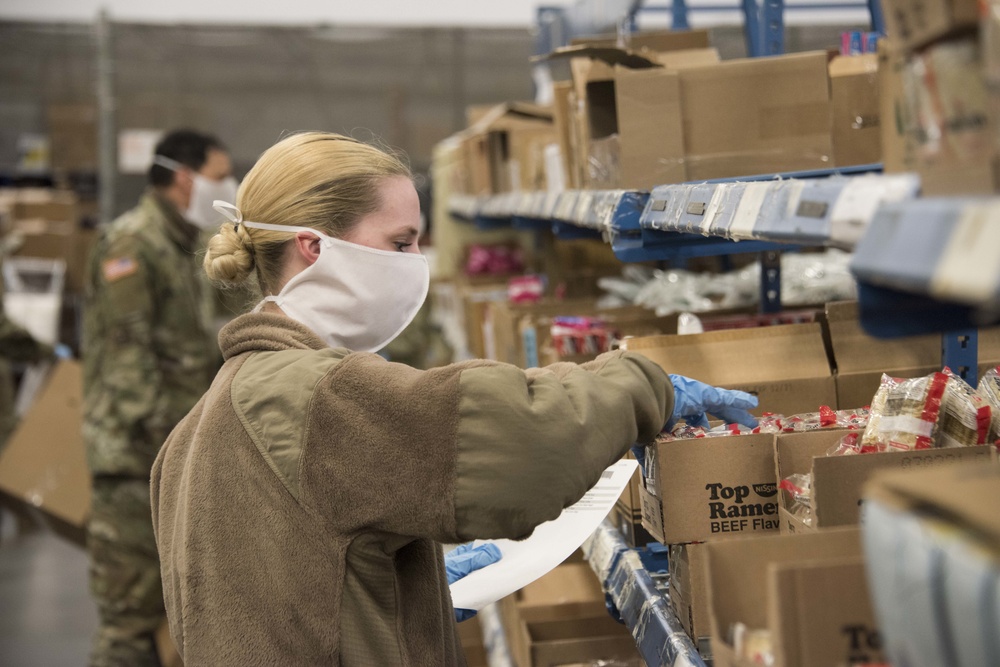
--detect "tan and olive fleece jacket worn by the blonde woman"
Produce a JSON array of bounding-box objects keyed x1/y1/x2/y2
[{"x1": 152, "y1": 314, "x2": 673, "y2": 667}]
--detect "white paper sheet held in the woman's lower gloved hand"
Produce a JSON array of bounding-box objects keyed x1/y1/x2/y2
[{"x1": 451, "y1": 459, "x2": 639, "y2": 611}]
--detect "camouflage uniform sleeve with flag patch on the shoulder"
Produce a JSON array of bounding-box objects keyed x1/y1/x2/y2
[{"x1": 95, "y1": 236, "x2": 173, "y2": 445}]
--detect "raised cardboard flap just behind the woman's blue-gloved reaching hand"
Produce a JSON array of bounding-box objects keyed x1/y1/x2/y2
[{"x1": 622, "y1": 323, "x2": 831, "y2": 386}]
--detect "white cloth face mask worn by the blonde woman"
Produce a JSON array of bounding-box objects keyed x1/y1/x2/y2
[{"x1": 215, "y1": 201, "x2": 430, "y2": 352}]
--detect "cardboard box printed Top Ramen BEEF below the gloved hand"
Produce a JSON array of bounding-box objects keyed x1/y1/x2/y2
[{"x1": 639, "y1": 433, "x2": 778, "y2": 544}]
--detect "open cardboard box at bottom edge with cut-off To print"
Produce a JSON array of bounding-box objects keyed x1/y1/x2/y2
[{"x1": 706, "y1": 529, "x2": 882, "y2": 667}]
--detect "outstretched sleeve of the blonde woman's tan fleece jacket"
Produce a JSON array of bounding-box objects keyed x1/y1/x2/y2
[{"x1": 300, "y1": 352, "x2": 673, "y2": 542}]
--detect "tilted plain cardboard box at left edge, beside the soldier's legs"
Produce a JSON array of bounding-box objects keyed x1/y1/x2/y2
[{"x1": 0, "y1": 360, "x2": 91, "y2": 543}]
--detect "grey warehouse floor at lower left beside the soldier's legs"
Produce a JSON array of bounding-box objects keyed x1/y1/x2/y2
[{"x1": 0, "y1": 512, "x2": 97, "y2": 667}]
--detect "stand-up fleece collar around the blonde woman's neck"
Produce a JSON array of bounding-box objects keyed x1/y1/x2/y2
[{"x1": 219, "y1": 313, "x2": 329, "y2": 360}]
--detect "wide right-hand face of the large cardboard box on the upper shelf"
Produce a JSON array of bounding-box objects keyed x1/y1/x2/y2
[{"x1": 680, "y1": 52, "x2": 833, "y2": 181}]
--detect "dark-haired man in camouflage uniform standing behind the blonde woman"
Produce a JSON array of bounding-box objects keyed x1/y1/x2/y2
[{"x1": 82, "y1": 131, "x2": 231, "y2": 667}]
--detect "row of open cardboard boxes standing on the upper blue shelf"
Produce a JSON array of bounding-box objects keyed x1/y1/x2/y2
[{"x1": 451, "y1": 30, "x2": 881, "y2": 195}]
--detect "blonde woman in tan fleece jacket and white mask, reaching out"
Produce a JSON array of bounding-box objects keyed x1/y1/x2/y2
[{"x1": 152, "y1": 133, "x2": 749, "y2": 667}]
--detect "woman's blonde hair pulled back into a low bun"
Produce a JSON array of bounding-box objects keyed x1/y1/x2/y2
[{"x1": 205, "y1": 132, "x2": 411, "y2": 294}]
